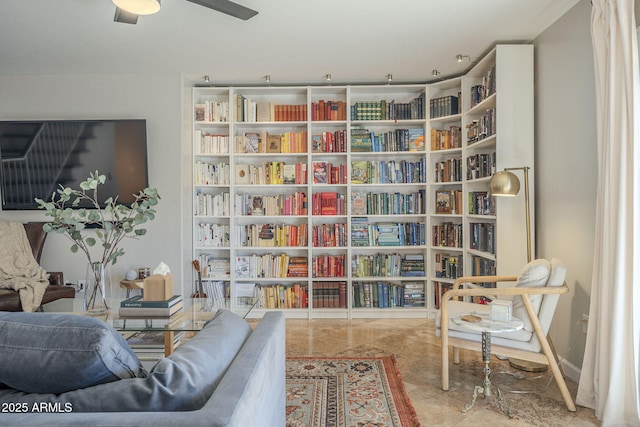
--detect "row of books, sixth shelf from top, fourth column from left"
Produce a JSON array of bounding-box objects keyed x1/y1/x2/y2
[{"x1": 351, "y1": 253, "x2": 424, "y2": 277}]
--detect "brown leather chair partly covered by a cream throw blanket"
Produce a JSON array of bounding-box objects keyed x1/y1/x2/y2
[{"x1": 0, "y1": 222, "x2": 75, "y2": 311}]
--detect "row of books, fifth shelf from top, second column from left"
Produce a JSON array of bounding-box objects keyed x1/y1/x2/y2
[{"x1": 234, "y1": 224, "x2": 309, "y2": 247}]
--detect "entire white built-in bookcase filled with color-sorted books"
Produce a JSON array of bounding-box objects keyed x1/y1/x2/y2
[{"x1": 190, "y1": 45, "x2": 533, "y2": 318}]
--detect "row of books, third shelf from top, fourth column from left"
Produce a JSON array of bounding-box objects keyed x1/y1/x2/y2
[{"x1": 351, "y1": 158, "x2": 427, "y2": 184}]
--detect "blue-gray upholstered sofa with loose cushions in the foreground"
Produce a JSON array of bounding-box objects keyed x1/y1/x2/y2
[{"x1": 0, "y1": 310, "x2": 285, "y2": 427}]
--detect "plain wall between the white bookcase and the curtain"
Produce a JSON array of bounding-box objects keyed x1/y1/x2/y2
[{"x1": 535, "y1": 1, "x2": 597, "y2": 374}]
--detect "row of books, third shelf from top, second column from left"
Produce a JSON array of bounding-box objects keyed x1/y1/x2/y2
[{"x1": 235, "y1": 162, "x2": 307, "y2": 185}]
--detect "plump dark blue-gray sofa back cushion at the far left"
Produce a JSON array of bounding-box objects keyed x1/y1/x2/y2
[{"x1": 0, "y1": 312, "x2": 146, "y2": 393}]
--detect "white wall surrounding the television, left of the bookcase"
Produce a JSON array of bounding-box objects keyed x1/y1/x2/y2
[{"x1": 0, "y1": 74, "x2": 190, "y2": 298}]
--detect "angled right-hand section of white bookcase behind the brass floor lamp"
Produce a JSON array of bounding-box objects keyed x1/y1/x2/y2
[{"x1": 428, "y1": 45, "x2": 535, "y2": 308}]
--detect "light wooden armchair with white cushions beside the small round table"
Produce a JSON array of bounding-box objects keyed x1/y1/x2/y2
[{"x1": 436, "y1": 258, "x2": 576, "y2": 411}]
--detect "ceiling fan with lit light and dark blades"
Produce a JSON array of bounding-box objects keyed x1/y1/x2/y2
[{"x1": 113, "y1": 0, "x2": 258, "y2": 24}]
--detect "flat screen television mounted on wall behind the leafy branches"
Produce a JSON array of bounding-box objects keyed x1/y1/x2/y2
[{"x1": 0, "y1": 119, "x2": 148, "y2": 210}]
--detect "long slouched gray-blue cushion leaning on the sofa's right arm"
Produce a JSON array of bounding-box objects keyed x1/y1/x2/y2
[{"x1": 0, "y1": 310, "x2": 251, "y2": 412}]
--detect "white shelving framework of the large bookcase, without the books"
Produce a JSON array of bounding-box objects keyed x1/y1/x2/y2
[{"x1": 190, "y1": 45, "x2": 534, "y2": 318}]
